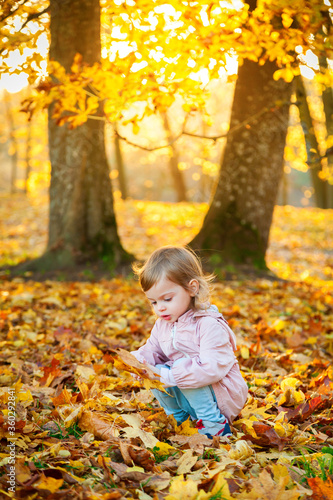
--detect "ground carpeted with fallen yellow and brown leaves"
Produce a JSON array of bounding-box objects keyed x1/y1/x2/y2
[{"x1": 0, "y1": 194, "x2": 333, "y2": 500}]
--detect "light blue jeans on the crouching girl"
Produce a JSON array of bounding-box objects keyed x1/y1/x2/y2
[{"x1": 152, "y1": 360, "x2": 223, "y2": 425}]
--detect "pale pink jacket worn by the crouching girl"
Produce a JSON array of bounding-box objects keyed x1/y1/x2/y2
[{"x1": 132, "y1": 306, "x2": 248, "y2": 422}]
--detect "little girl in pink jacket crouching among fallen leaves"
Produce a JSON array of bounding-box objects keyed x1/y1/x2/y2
[{"x1": 132, "y1": 246, "x2": 247, "y2": 438}]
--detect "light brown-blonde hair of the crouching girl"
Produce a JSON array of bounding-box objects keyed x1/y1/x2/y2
[{"x1": 133, "y1": 246, "x2": 214, "y2": 309}]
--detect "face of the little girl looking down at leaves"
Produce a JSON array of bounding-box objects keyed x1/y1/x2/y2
[{"x1": 145, "y1": 277, "x2": 199, "y2": 323}]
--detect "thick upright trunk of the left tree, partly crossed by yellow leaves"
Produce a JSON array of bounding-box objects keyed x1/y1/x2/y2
[{"x1": 39, "y1": 0, "x2": 129, "y2": 269}]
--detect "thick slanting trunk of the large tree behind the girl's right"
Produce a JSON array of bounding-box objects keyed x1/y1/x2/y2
[{"x1": 190, "y1": 57, "x2": 291, "y2": 267}]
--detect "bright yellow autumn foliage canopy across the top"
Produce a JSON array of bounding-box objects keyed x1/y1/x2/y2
[{"x1": 2, "y1": 0, "x2": 333, "y2": 127}]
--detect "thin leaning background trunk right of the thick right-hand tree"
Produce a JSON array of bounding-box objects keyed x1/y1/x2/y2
[{"x1": 296, "y1": 76, "x2": 327, "y2": 208}]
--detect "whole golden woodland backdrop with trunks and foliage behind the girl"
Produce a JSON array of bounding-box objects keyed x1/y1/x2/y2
[{"x1": 0, "y1": 0, "x2": 333, "y2": 278}]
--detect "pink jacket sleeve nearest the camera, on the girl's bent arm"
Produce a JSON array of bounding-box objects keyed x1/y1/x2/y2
[{"x1": 171, "y1": 317, "x2": 237, "y2": 389}]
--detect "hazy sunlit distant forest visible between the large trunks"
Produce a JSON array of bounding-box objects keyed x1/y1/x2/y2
[{"x1": 0, "y1": 74, "x2": 326, "y2": 207}]
